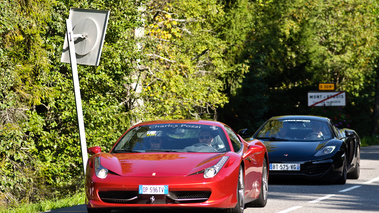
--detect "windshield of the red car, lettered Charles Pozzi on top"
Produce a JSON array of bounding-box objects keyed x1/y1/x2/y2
[{"x1": 112, "y1": 123, "x2": 230, "y2": 153}]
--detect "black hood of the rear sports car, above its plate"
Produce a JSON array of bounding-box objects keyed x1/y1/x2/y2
[{"x1": 264, "y1": 141, "x2": 338, "y2": 162}]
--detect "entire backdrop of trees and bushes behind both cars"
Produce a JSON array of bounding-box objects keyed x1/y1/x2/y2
[{"x1": 0, "y1": 0, "x2": 379, "y2": 212}]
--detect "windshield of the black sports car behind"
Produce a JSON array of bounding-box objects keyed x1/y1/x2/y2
[{"x1": 255, "y1": 119, "x2": 332, "y2": 141}]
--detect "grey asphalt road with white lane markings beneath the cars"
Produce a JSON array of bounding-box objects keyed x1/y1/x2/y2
[{"x1": 46, "y1": 146, "x2": 379, "y2": 213}]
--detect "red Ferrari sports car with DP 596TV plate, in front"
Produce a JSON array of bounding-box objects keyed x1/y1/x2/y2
[{"x1": 85, "y1": 120, "x2": 268, "y2": 213}]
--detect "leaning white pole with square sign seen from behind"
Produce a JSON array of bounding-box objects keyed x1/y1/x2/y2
[{"x1": 61, "y1": 9, "x2": 109, "y2": 174}]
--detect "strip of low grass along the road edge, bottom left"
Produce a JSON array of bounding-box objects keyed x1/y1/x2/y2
[{"x1": 0, "y1": 192, "x2": 85, "y2": 213}]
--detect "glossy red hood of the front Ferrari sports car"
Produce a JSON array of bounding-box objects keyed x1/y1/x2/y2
[{"x1": 100, "y1": 153, "x2": 229, "y2": 177}]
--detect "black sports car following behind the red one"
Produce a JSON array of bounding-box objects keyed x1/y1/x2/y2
[{"x1": 245, "y1": 115, "x2": 361, "y2": 184}]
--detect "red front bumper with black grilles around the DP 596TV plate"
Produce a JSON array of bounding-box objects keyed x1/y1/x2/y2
[{"x1": 86, "y1": 173, "x2": 238, "y2": 208}]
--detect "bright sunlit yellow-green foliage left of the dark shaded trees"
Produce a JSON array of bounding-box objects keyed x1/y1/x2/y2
[{"x1": 0, "y1": 1, "x2": 232, "y2": 207}]
